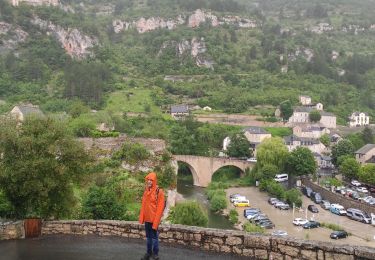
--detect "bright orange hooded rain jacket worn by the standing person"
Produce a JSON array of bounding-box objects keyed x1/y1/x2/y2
[{"x1": 139, "y1": 172, "x2": 165, "y2": 230}]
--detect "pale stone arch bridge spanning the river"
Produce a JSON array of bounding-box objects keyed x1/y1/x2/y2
[{"x1": 173, "y1": 155, "x2": 254, "y2": 187}]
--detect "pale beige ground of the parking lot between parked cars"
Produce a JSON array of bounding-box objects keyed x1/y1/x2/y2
[{"x1": 227, "y1": 187, "x2": 375, "y2": 247}]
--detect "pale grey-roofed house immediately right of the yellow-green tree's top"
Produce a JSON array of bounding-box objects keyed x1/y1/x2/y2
[{"x1": 284, "y1": 135, "x2": 326, "y2": 154}]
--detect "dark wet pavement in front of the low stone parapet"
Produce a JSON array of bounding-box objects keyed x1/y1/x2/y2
[{"x1": 0, "y1": 235, "x2": 244, "y2": 260}]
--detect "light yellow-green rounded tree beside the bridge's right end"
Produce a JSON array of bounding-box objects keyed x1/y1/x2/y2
[{"x1": 257, "y1": 137, "x2": 289, "y2": 171}]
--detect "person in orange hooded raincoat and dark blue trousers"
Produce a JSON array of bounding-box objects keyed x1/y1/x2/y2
[{"x1": 139, "y1": 172, "x2": 165, "y2": 260}]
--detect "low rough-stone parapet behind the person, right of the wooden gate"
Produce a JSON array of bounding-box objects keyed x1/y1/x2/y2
[{"x1": 42, "y1": 220, "x2": 375, "y2": 260}]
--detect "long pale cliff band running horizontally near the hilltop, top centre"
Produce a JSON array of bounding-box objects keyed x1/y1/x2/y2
[{"x1": 112, "y1": 9, "x2": 257, "y2": 33}]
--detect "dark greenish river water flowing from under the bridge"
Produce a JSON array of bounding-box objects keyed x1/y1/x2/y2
[{"x1": 177, "y1": 178, "x2": 233, "y2": 229}]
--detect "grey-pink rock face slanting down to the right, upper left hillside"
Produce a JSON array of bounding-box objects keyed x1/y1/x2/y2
[{"x1": 32, "y1": 17, "x2": 99, "y2": 59}]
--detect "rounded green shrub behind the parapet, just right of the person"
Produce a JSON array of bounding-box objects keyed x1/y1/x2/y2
[{"x1": 168, "y1": 201, "x2": 208, "y2": 227}]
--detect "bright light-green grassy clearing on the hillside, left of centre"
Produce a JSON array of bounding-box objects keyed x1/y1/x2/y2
[{"x1": 105, "y1": 88, "x2": 161, "y2": 114}]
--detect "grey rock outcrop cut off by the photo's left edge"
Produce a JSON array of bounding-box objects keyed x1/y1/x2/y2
[{"x1": 0, "y1": 22, "x2": 29, "y2": 53}]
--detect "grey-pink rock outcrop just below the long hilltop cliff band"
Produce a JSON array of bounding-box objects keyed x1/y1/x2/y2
[{"x1": 158, "y1": 37, "x2": 215, "y2": 69}]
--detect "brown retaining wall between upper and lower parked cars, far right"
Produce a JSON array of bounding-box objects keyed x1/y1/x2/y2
[{"x1": 302, "y1": 178, "x2": 375, "y2": 213}]
